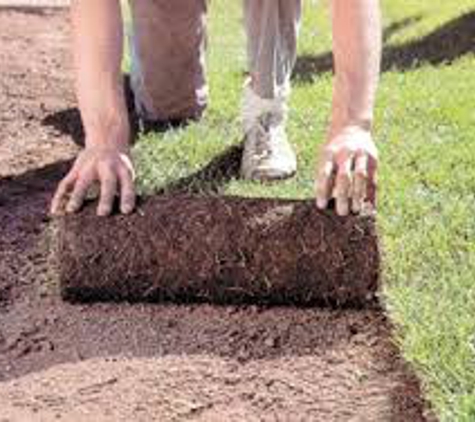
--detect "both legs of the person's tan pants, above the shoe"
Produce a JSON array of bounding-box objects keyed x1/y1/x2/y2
[{"x1": 130, "y1": 0, "x2": 301, "y2": 120}]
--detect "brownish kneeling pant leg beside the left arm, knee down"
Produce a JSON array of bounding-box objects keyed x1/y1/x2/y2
[{"x1": 130, "y1": 0, "x2": 207, "y2": 121}]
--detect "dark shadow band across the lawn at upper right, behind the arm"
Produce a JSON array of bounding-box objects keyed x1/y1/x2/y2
[{"x1": 293, "y1": 12, "x2": 475, "y2": 83}]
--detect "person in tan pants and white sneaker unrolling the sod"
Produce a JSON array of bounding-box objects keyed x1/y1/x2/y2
[{"x1": 51, "y1": 0, "x2": 381, "y2": 216}]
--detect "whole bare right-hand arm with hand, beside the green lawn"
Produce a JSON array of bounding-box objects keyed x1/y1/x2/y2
[{"x1": 317, "y1": 0, "x2": 381, "y2": 215}]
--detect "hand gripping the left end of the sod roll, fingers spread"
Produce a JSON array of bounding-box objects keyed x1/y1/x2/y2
[{"x1": 51, "y1": 146, "x2": 136, "y2": 216}]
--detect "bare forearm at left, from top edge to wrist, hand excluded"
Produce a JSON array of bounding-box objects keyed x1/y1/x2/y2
[{"x1": 71, "y1": 0, "x2": 130, "y2": 147}]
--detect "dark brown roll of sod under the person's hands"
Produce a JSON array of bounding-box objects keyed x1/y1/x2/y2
[{"x1": 55, "y1": 196, "x2": 380, "y2": 306}]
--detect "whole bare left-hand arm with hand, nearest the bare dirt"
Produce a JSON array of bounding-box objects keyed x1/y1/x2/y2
[{"x1": 52, "y1": 0, "x2": 135, "y2": 215}]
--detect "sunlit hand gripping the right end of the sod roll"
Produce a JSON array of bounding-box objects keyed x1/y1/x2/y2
[{"x1": 315, "y1": 126, "x2": 378, "y2": 216}]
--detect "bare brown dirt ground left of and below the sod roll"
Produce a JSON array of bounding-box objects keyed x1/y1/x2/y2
[{"x1": 0, "y1": 8, "x2": 436, "y2": 422}]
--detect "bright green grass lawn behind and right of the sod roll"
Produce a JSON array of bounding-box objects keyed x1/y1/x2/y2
[{"x1": 129, "y1": 0, "x2": 475, "y2": 421}]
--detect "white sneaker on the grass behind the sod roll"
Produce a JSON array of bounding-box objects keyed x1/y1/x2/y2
[{"x1": 241, "y1": 84, "x2": 297, "y2": 181}]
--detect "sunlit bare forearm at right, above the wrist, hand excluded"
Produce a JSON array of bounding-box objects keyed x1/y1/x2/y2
[{"x1": 329, "y1": 0, "x2": 382, "y2": 137}]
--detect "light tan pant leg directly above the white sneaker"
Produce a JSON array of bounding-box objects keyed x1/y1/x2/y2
[{"x1": 244, "y1": 0, "x2": 302, "y2": 99}]
